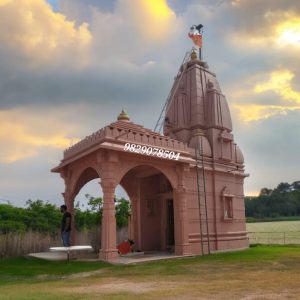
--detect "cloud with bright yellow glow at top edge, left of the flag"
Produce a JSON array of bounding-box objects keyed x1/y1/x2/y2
[{"x1": 60, "y1": 0, "x2": 178, "y2": 47}]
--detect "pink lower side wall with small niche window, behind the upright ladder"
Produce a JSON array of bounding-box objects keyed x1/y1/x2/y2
[{"x1": 186, "y1": 169, "x2": 248, "y2": 254}]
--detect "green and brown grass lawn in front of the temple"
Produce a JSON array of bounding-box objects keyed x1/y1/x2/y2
[{"x1": 0, "y1": 246, "x2": 300, "y2": 300}]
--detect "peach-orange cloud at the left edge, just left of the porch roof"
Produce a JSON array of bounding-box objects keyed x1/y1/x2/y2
[{"x1": 0, "y1": 109, "x2": 79, "y2": 163}]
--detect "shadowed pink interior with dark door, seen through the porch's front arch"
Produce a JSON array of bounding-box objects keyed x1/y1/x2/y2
[{"x1": 120, "y1": 165, "x2": 175, "y2": 252}]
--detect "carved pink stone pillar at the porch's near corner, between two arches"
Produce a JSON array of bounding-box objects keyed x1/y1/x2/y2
[{"x1": 99, "y1": 178, "x2": 118, "y2": 261}]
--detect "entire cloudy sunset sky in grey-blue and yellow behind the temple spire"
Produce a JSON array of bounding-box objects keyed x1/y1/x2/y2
[{"x1": 0, "y1": 0, "x2": 300, "y2": 206}]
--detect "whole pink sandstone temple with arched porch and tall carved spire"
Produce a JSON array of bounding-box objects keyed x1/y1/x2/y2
[{"x1": 52, "y1": 48, "x2": 248, "y2": 261}]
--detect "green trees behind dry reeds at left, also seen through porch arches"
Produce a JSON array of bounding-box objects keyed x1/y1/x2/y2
[{"x1": 0, "y1": 194, "x2": 130, "y2": 235}]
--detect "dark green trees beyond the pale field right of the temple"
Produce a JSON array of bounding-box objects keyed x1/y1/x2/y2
[{"x1": 245, "y1": 181, "x2": 300, "y2": 221}]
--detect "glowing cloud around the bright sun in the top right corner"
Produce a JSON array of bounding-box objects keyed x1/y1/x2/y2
[{"x1": 229, "y1": 5, "x2": 300, "y2": 51}]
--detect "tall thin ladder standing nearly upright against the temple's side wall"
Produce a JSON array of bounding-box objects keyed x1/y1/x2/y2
[{"x1": 195, "y1": 139, "x2": 210, "y2": 255}]
